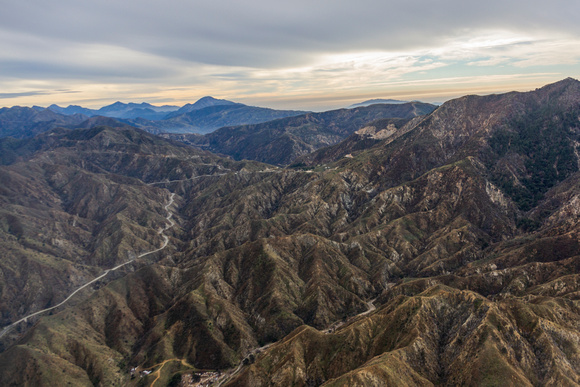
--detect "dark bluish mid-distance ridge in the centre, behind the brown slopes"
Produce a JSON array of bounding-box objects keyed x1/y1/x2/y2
[{"x1": 169, "y1": 103, "x2": 435, "y2": 165}]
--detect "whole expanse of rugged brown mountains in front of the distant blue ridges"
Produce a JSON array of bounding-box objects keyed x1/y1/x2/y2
[{"x1": 0, "y1": 79, "x2": 580, "y2": 386}]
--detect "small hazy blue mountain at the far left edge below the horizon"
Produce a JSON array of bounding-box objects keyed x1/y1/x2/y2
[{"x1": 0, "y1": 106, "x2": 87, "y2": 138}]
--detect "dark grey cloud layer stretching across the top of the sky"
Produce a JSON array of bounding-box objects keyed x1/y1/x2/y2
[{"x1": 0, "y1": 0, "x2": 580, "y2": 67}]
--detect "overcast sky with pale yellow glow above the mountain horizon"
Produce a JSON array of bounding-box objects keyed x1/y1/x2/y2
[{"x1": 0, "y1": 0, "x2": 580, "y2": 111}]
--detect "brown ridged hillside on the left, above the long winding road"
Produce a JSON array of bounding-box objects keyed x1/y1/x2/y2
[{"x1": 0, "y1": 127, "x2": 256, "y2": 346}]
